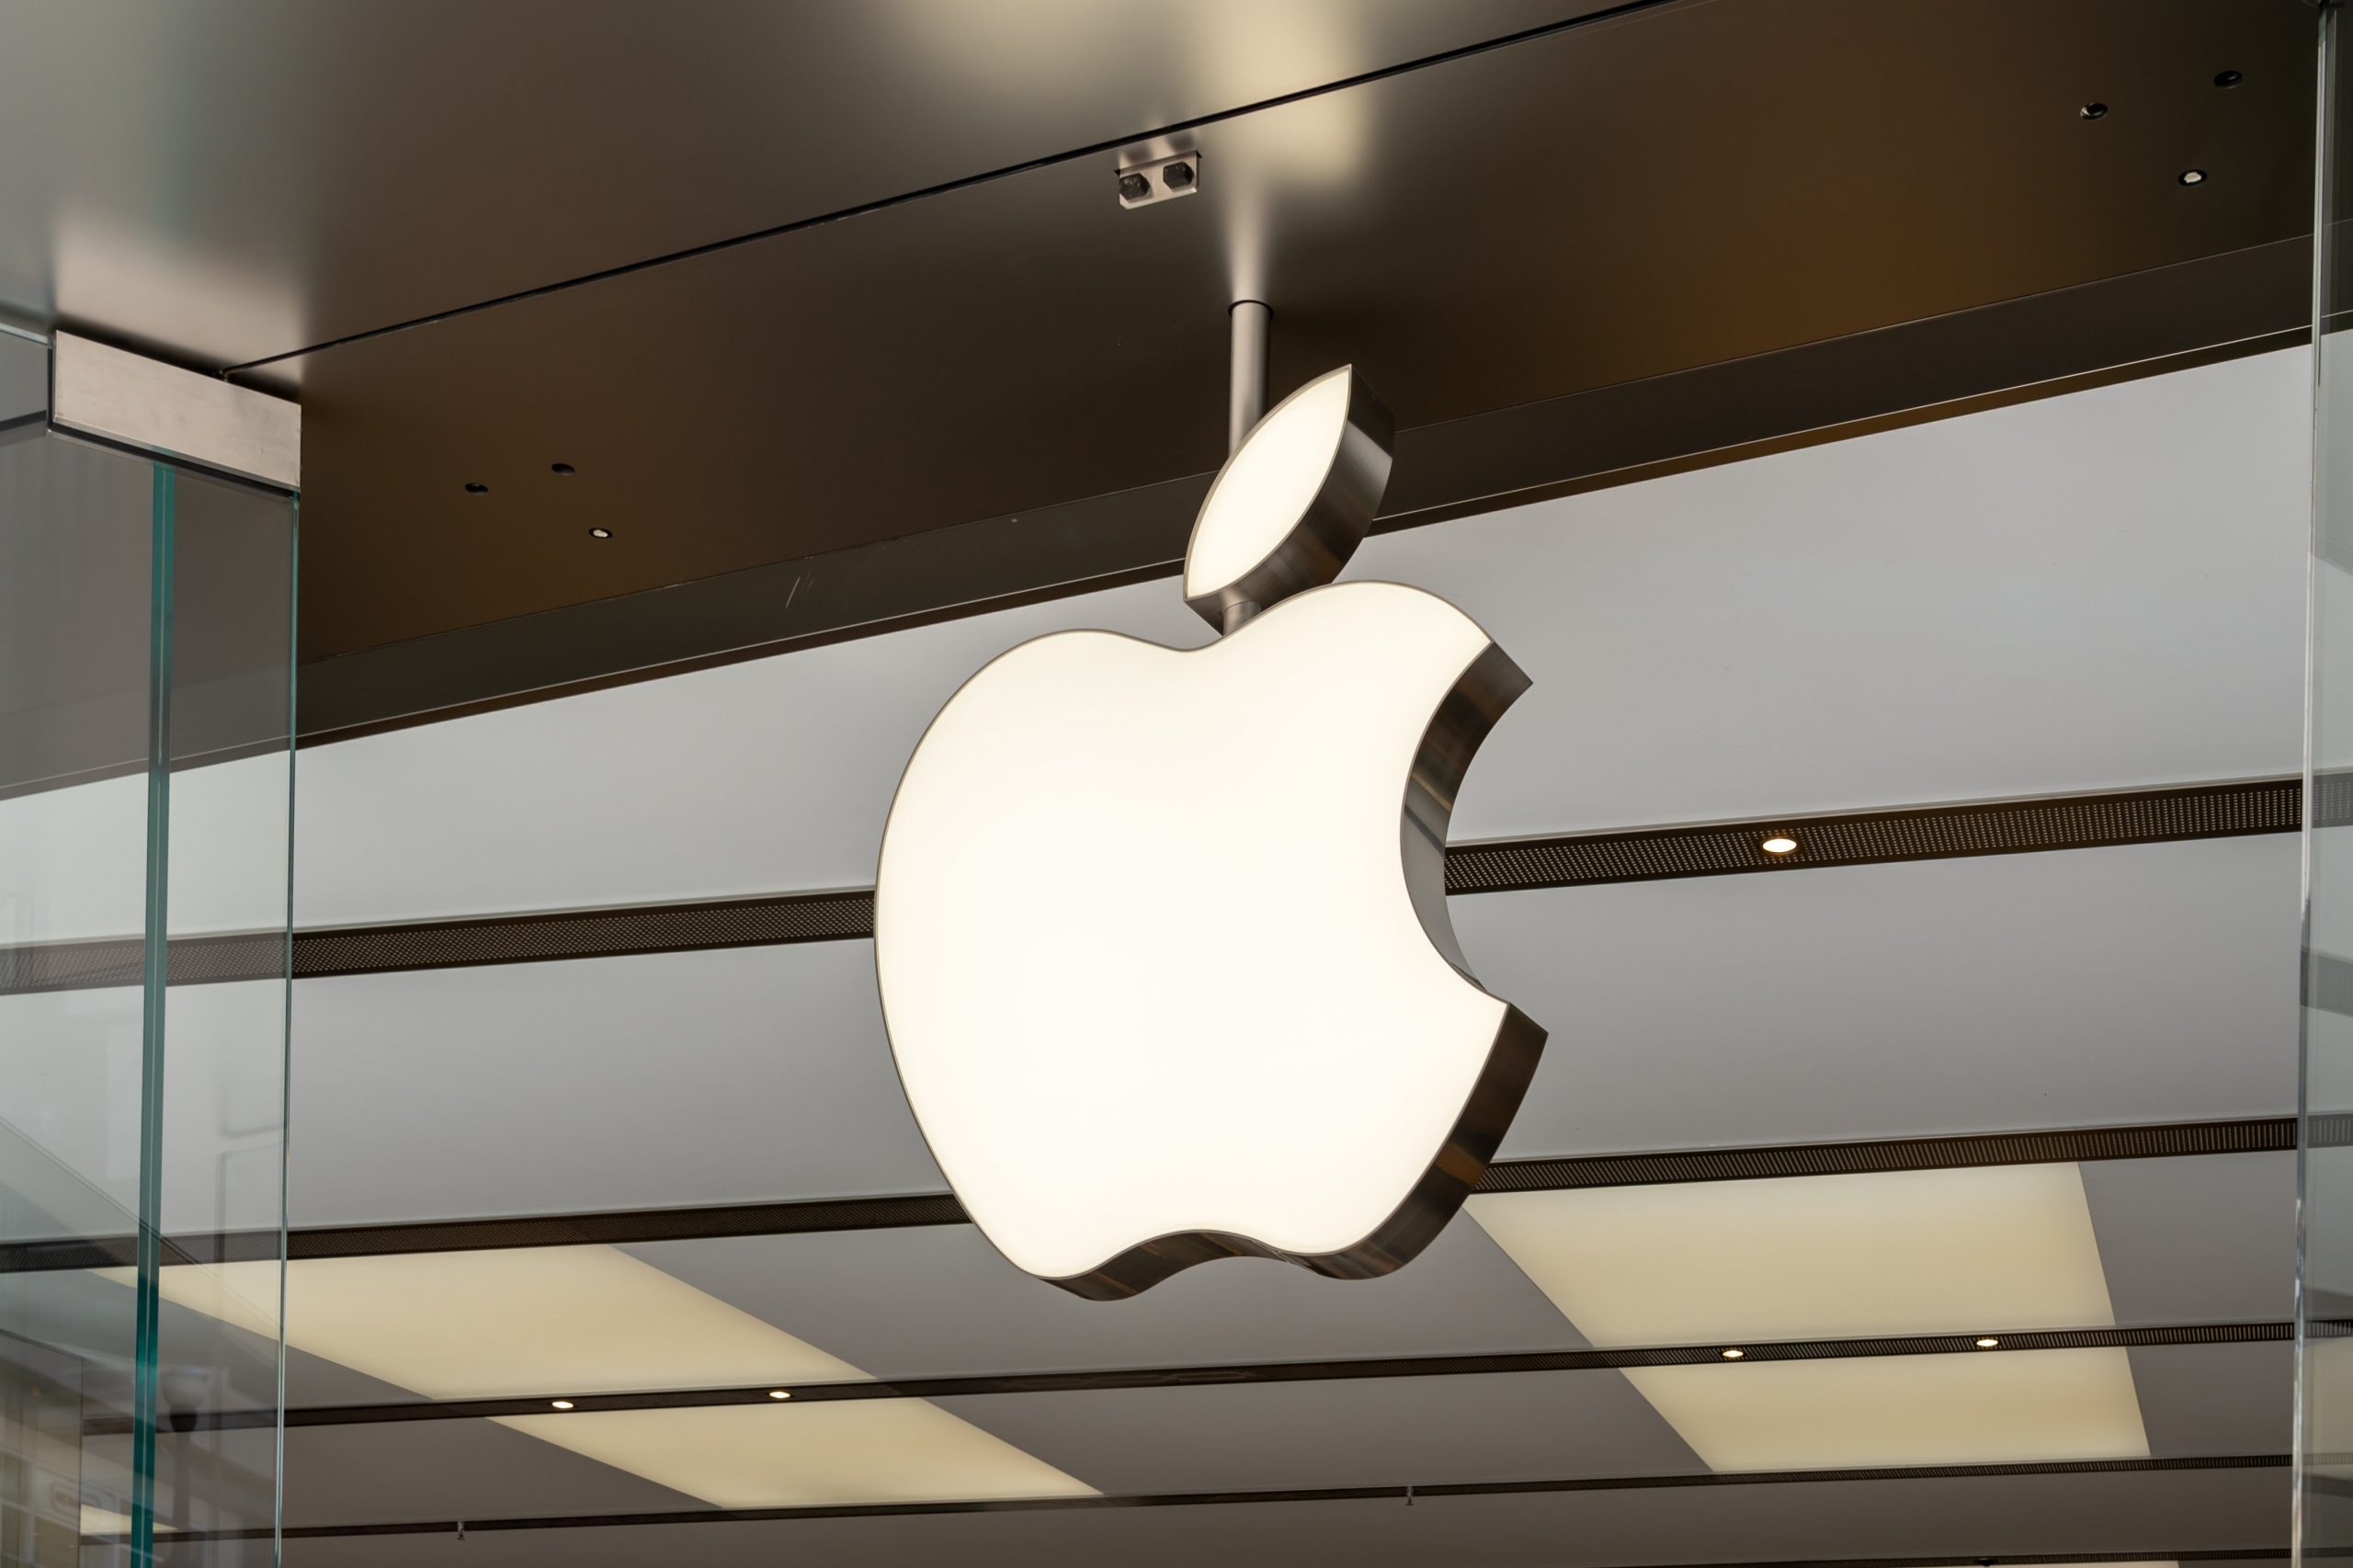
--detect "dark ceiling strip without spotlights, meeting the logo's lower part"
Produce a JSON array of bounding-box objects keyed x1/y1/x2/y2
[{"x1": 0, "y1": 1114, "x2": 2278, "y2": 1274}]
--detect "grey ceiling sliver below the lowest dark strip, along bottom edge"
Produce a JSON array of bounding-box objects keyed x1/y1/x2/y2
[{"x1": 267, "y1": 1469, "x2": 2287, "y2": 1568}]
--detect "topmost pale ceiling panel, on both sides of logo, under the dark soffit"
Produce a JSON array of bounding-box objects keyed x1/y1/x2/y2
[{"x1": 297, "y1": 351, "x2": 2308, "y2": 926}]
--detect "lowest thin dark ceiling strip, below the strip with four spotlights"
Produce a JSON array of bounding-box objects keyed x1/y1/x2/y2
[{"x1": 106, "y1": 1452, "x2": 2290, "y2": 1535}]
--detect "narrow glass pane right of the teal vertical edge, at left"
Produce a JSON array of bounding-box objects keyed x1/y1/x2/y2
[{"x1": 155, "y1": 469, "x2": 294, "y2": 1565}]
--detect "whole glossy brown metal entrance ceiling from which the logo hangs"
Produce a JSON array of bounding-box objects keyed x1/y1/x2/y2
[{"x1": 0, "y1": 0, "x2": 2313, "y2": 657}]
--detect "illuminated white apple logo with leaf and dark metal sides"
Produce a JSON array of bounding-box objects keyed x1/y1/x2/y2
[{"x1": 875, "y1": 368, "x2": 1543, "y2": 1300}]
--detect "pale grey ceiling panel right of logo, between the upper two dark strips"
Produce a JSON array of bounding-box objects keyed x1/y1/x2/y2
[{"x1": 1449, "y1": 834, "x2": 2299, "y2": 1156}]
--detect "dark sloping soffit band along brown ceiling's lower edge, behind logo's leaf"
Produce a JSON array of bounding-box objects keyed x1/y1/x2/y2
[{"x1": 284, "y1": 240, "x2": 2311, "y2": 744}]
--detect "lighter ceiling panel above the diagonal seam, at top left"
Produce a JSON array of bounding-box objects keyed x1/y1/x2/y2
[{"x1": 0, "y1": 0, "x2": 1597, "y2": 368}]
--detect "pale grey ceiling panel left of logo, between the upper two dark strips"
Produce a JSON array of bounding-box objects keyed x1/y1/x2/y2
[{"x1": 290, "y1": 942, "x2": 941, "y2": 1224}]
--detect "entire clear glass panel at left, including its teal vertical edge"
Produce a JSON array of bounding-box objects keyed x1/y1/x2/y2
[{"x1": 0, "y1": 336, "x2": 294, "y2": 1565}]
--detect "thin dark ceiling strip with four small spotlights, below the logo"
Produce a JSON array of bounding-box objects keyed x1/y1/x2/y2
[{"x1": 119, "y1": 1321, "x2": 2294, "y2": 1437}]
